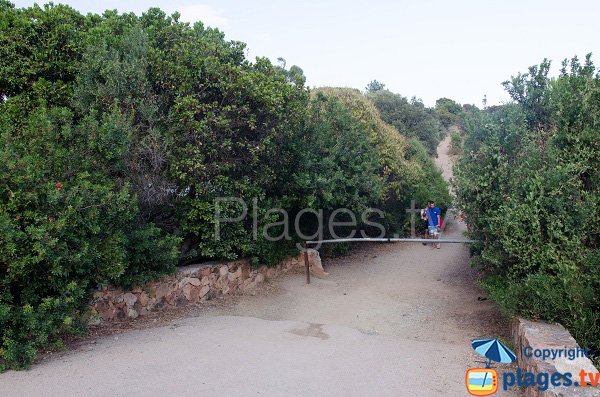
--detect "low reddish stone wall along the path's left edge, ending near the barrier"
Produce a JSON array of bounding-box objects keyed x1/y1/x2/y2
[{"x1": 90, "y1": 249, "x2": 327, "y2": 323}]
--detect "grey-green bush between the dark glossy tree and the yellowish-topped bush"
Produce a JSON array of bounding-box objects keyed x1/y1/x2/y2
[{"x1": 294, "y1": 91, "x2": 383, "y2": 213}]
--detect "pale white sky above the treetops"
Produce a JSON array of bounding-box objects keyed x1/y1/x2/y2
[{"x1": 13, "y1": 0, "x2": 600, "y2": 106}]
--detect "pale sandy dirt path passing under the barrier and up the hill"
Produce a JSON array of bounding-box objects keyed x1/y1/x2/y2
[{"x1": 0, "y1": 135, "x2": 512, "y2": 397}]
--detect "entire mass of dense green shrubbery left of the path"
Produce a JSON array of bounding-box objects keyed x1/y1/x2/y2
[{"x1": 0, "y1": 0, "x2": 449, "y2": 368}]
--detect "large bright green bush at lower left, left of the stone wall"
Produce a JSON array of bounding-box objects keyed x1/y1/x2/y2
[{"x1": 0, "y1": 104, "x2": 178, "y2": 366}]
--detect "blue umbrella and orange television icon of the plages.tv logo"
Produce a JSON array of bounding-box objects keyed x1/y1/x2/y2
[{"x1": 465, "y1": 338, "x2": 517, "y2": 396}]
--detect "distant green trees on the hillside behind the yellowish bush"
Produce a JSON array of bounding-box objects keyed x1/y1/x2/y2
[{"x1": 368, "y1": 90, "x2": 443, "y2": 155}]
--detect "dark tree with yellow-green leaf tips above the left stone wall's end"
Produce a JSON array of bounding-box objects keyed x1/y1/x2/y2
[{"x1": 169, "y1": 55, "x2": 307, "y2": 259}]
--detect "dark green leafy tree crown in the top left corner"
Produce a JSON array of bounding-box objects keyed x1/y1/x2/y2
[{"x1": 0, "y1": 1, "x2": 90, "y2": 105}]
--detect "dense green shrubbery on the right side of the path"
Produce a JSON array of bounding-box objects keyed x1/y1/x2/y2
[{"x1": 455, "y1": 57, "x2": 600, "y2": 348}]
